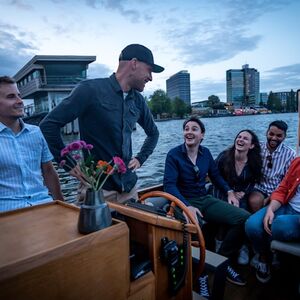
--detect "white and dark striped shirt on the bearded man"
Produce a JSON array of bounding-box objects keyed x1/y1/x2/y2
[{"x1": 255, "y1": 142, "x2": 296, "y2": 195}]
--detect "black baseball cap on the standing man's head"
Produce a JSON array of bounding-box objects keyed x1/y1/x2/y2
[{"x1": 119, "y1": 44, "x2": 165, "y2": 73}]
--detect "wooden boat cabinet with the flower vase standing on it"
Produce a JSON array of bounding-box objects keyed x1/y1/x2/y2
[{"x1": 0, "y1": 203, "x2": 130, "y2": 300}]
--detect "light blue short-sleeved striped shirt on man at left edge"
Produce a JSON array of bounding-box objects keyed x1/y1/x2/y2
[{"x1": 0, "y1": 120, "x2": 53, "y2": 211}]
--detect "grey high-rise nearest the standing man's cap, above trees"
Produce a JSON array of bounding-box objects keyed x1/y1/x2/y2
[{"x1": 166, "y1": 70, "x2": 191, "y2": 105}]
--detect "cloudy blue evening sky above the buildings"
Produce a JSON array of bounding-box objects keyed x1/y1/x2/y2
[{"x1": 0, "y1": 0, "x2": 300, "y2": 102}]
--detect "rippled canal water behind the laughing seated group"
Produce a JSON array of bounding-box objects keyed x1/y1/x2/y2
[{"x1": 132, "y1": 113, "x2": 298, "y2": 188}]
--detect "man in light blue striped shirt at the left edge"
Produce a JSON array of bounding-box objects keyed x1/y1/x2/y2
[{"x1": 0, "y1": 76, "x2": 63, "y2": 212}]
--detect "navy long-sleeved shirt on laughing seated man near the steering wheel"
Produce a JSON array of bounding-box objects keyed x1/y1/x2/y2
[{"x1": 164, "y1": 144, "x2": 230, "y2": 205}]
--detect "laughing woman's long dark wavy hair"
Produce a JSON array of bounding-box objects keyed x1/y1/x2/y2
[{"x1": 222, "y1": 129, "x2": 262, "y2": 183}]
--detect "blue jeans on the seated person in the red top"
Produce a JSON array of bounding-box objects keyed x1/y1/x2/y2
[{"x1": 245, "y1": 204, "x2": 300, "y2": 254}]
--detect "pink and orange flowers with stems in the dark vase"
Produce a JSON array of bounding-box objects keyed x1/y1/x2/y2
[{"x1": 60, "y1": 140, "x2": 126, "y2": 191}]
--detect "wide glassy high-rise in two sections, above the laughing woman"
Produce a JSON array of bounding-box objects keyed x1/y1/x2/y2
[{"x1": 226, "y1": 65, "x2": 260, "y2": 107}]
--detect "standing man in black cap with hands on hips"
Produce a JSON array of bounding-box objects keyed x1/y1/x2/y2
[{"x1": 40, "y1": 44, "x2": 164, "y2": 202}]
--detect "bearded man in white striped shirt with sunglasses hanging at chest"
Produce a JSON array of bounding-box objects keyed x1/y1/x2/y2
[{"x1": 248, "y1": 120, "x2": 296, "y2": 212}]
